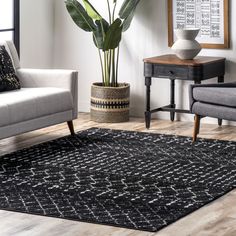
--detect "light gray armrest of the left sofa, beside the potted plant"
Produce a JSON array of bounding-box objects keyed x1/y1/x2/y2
[{"x1": 16, "y1": 68, "x2": 78, "y2": 119}]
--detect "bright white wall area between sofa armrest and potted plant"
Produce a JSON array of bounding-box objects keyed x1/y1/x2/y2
[{"x1": 54, "y1": 0, "x2": 104, "y2": 111}]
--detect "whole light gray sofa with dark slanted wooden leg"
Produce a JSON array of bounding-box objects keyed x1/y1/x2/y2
[{"x1": 0, "y1": 41, "x2": 78, "y2": 139}]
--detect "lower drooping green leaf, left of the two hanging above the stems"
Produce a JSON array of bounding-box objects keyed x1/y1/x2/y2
[{"x1": 93, "y1": 19, "x2": 109, "y2": 50}]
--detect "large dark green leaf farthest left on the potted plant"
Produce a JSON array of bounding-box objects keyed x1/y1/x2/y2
[{"x1": 65, "y1": 0, "x2": 96, "y2": 32}]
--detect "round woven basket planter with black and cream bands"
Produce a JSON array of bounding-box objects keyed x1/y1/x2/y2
[{"x1": 91, "y1": 83, "x2": 130, "y2": 123}]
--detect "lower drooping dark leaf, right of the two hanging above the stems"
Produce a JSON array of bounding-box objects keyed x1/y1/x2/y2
[{"x1": 103, "y1": 18, "x2": 123, "y2": 51}]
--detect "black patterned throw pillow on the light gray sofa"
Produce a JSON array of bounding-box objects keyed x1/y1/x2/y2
[{"x1": 0, "y1": 46, "x2": 20, "y2": 92}]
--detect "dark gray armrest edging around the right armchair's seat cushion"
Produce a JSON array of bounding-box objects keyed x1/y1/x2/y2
[{"x1": 189, "y1": 82, "x2": 236, "y2": 112}]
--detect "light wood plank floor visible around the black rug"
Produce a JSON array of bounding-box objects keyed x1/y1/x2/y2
[{"x1": 0, "y1": 114, "x2": 236, "y2": 236}]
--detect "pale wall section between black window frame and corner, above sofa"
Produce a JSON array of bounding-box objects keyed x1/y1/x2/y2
[{"x1": 20, "y1": 0, "x2": 54, "y2": 68}]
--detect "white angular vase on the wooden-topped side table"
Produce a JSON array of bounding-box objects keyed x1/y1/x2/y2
[{"x1": 171, "y1": 29, "x2": 202, "y2": 60}]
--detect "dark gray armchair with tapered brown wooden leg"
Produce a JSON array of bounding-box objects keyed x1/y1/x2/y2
[{"x1": 189, "y1": 82, "x2": 236, "y2": 141}]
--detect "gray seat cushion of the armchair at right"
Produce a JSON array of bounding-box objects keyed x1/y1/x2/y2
[{"x1": 193, "y1": 87, "x2": 236, "y2": 107}]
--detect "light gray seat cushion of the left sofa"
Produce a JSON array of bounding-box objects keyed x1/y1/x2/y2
[{"x1": 0, "y1": 88, "x2": 73, "y2": 127}]
